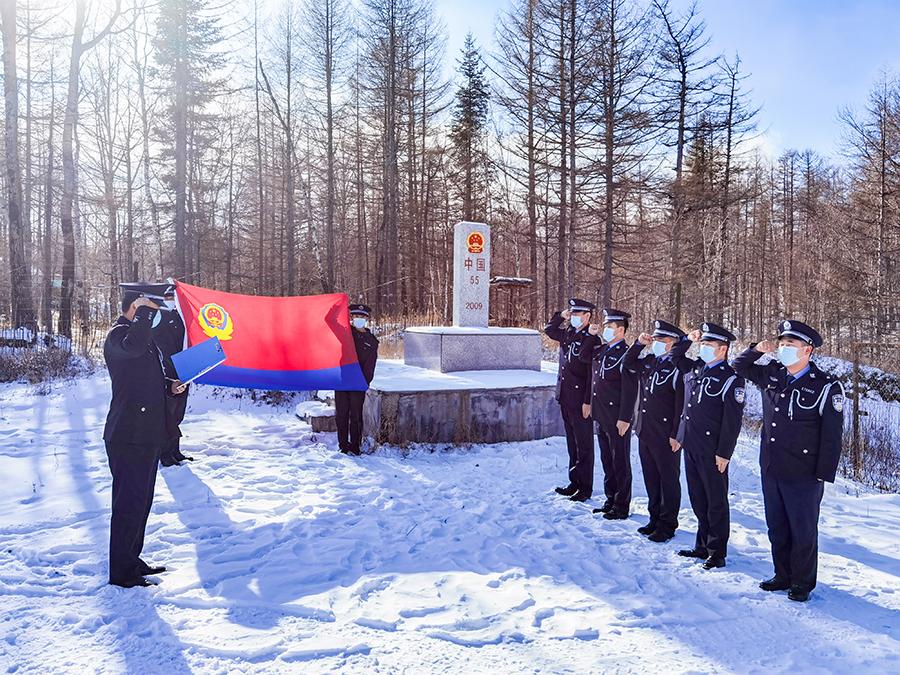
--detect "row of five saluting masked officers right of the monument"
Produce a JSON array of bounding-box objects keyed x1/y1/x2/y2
[{"x1": 544, "y1": 298, "x2": 844, "y2": 602}]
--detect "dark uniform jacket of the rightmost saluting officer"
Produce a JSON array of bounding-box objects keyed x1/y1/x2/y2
[{"x1": 734, "y1": 345, "x2": 844, "y2": 483}]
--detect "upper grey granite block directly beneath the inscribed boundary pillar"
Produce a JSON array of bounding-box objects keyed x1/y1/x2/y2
[{"x1": 403, "y1": 326, "x2": 541, "y2": 373}]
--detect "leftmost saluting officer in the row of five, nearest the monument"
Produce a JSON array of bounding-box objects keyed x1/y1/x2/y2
[{"x1": 544, "y1": 298, "x2": 596, "y2": 502}]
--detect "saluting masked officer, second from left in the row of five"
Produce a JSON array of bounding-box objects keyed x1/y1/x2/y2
[{"x1": 579, "y1": 308, "x2": 637, "y2": 520}]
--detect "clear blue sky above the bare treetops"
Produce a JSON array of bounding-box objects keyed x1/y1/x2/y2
[{"x1": 434, "y1": 0, "x2": 900, "y2": 159}]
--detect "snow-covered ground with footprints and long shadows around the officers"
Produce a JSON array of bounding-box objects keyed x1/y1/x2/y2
[{"x1": 0, "y1": 375, "x2": 900, "y2": 674}]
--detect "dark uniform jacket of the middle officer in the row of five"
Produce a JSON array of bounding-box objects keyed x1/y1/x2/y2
[{"x1": 625, "y1": 340, "x2": 690, "y2": 443}]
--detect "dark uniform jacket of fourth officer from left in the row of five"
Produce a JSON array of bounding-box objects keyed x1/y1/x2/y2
[{"x1": 673, "y1": 340, "x2": 744, "y2": 459}]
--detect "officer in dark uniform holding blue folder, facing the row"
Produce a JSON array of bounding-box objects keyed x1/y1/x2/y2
[{"x1": 103, "y1": 290, "x2": 183, "y2": 588}]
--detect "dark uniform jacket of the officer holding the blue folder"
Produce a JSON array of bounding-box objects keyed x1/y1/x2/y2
[{"x1": 103, "y1": 307, "x2": 184, "y2": 447}]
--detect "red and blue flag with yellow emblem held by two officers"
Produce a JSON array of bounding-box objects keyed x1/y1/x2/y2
[{"x1": 176, "y1": 282, "x2": 368, "y2": 391}]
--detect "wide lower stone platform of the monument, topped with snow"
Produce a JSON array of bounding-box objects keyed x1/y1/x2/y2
[{"x1": 363, "y1": 361, "x2": 565, "y2": 445}]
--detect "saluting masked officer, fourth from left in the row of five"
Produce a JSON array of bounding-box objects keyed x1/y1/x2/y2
[{"x1": 672, "y1": 323, "x2": 744, "y2": 570}]
